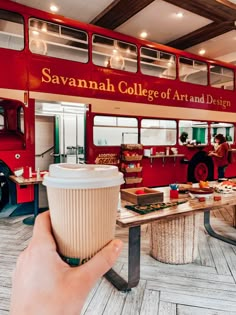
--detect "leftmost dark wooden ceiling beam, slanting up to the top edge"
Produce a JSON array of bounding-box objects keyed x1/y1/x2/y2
[{"x1": 90, "y1": 0, "x2": 155, "y2": 30}]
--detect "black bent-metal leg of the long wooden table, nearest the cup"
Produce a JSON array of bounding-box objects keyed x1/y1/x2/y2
[{"x1": 105, "y1": 226, "x2": 140, "y2": 292}]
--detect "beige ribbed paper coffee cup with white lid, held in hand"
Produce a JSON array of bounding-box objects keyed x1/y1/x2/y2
[{"x1": 43, "y1": 164, "x2": 123, "y2": 265}]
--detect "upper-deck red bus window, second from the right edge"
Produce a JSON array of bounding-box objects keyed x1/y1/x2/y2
[{"x1": 179, "y1": 57, "x2": 207, "y2": 85}]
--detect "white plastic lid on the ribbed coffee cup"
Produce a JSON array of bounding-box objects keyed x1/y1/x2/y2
[{"x1": 43, "y1": 163, "x2": 124, "y2": 189}]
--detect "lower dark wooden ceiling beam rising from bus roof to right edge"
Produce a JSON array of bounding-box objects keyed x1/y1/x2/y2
[{"x1": 166, "y1": 21, "x2": 235, "y2": 50}]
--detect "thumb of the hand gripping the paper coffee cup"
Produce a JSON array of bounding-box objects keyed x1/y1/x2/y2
[{"x1": 74, "y1": 239, "x2": 123, "y2": 287}]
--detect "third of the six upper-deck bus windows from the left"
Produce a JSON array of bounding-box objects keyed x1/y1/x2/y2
[{"x1": 92, "y1": 35, "x2": 137, "y2": 72}]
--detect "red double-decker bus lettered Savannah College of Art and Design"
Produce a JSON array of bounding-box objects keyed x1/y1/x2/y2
[{"x1": 0, "y1": 0, "x2": 236, "y2": 214}]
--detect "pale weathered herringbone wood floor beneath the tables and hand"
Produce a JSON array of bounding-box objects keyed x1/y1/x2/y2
[{"x1": 0, "y1": 208, "x2": 236, "y2": 315}]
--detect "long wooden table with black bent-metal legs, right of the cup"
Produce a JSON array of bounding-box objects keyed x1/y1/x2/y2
[{"x1": 105, "y1": 188, "x2": 236, "y2": 291}]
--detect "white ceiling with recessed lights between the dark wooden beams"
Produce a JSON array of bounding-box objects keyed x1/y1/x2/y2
[{"x1": 13, "y1": 0, "x2": 236, "y2": 64}]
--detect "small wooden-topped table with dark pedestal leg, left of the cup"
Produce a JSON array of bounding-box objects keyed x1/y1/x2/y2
[{"x1": 9, "y1": 175, "x2": 43, "y2": 225}]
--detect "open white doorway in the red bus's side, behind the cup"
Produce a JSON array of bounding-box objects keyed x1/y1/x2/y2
[{"x1": 36, "y1": 102, "x2": 86, "y2": 169}]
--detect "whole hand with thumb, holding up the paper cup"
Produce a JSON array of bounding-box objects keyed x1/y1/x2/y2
[{"x1": 10, "y1": 211, "x2": 123, "y2": 315}]
